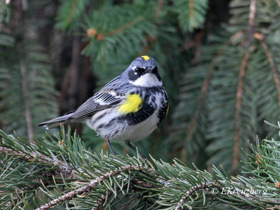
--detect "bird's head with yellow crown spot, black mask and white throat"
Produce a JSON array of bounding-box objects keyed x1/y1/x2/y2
[{"x1": 123, "y1": 55, "x2": 162, "y2": 87}]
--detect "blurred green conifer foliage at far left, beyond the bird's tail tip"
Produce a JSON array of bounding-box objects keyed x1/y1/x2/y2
[{"x1": 0, "y1": 1, "x2": 57, "y2": 141}]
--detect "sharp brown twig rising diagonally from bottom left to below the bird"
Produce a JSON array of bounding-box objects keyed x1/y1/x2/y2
[{"x1": 36, "y1": 165, "x2": 152, "y2": 210}]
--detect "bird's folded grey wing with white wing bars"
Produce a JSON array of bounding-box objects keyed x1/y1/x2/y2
[{"x1": 68, "y1": 77, "x2": 125, "y2": 120}]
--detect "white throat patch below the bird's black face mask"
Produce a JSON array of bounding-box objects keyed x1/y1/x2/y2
[{"x1": 130, "y1": 73, "x2": 162, "y2": 87}]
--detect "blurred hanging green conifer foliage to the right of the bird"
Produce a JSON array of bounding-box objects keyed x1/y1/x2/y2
[{"x1": 173, "y1": 0, "x2": 280, "y2": 173}]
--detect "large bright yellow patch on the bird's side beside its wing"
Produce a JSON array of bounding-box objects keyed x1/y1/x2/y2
[{"x1": 119, "y1": 94, "x2": 143, "y2": 114}]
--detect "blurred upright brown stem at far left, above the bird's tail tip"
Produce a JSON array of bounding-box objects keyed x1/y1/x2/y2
[{"x1": 20, "y1": 56, "x2": 34, "y2": 143}]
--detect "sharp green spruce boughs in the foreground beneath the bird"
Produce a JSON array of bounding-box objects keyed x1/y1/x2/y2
[{"x1": 0, "y1": 126, "x2": 280, "y2": 210}]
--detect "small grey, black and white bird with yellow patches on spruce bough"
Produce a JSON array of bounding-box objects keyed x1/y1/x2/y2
[{"x1": 38, "y1": 55, "x2": 169, "y2": 157}]
